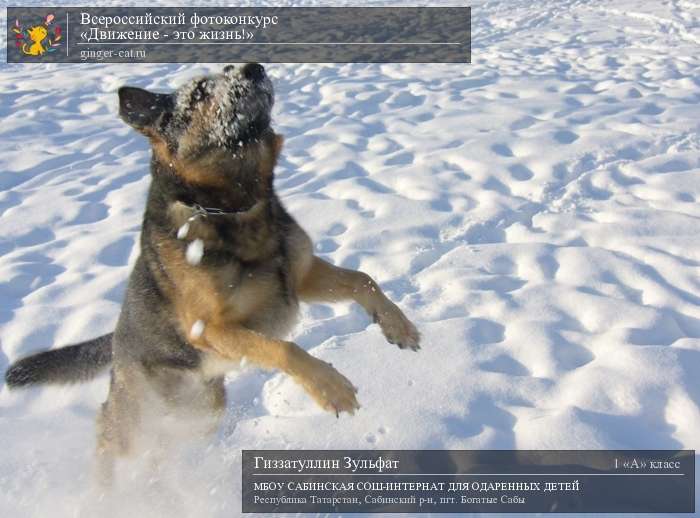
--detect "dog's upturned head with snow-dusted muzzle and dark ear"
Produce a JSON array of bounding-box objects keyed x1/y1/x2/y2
[{"x1": 119, "y1": 63, "x2": 281, "y2": 189}]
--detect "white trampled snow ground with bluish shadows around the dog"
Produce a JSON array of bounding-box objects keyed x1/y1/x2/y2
[{"x1": 0, "y1": 0, "x2": 700, "y2": 517}]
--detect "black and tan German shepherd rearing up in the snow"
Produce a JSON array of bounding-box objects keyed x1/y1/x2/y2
[{"x1": 5, "y1": 63, "x2": 420, "y2": 483}]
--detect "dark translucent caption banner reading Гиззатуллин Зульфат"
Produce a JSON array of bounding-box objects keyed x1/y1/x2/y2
[{"x1": 242, "y1": 450, "x2": 695, "y2": 513}]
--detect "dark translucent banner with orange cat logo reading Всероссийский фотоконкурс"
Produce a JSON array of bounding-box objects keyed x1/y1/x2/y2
[{"x1": 7, "y1": 7, "x2": 471, "y2": 63}]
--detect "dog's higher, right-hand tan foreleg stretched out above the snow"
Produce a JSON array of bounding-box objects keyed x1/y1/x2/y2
[{"x1": 297, "y1": 256, "x2": 420, "y2": 351}]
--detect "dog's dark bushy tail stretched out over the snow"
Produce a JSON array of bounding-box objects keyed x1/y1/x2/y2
[{"x1": 5, "y1": 333, "x2": 113, "y2": 388}]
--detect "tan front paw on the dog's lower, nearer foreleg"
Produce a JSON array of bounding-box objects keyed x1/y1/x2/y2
[{"x1": 298, "y1": 356, "x2": 360, "y2": 416}]
